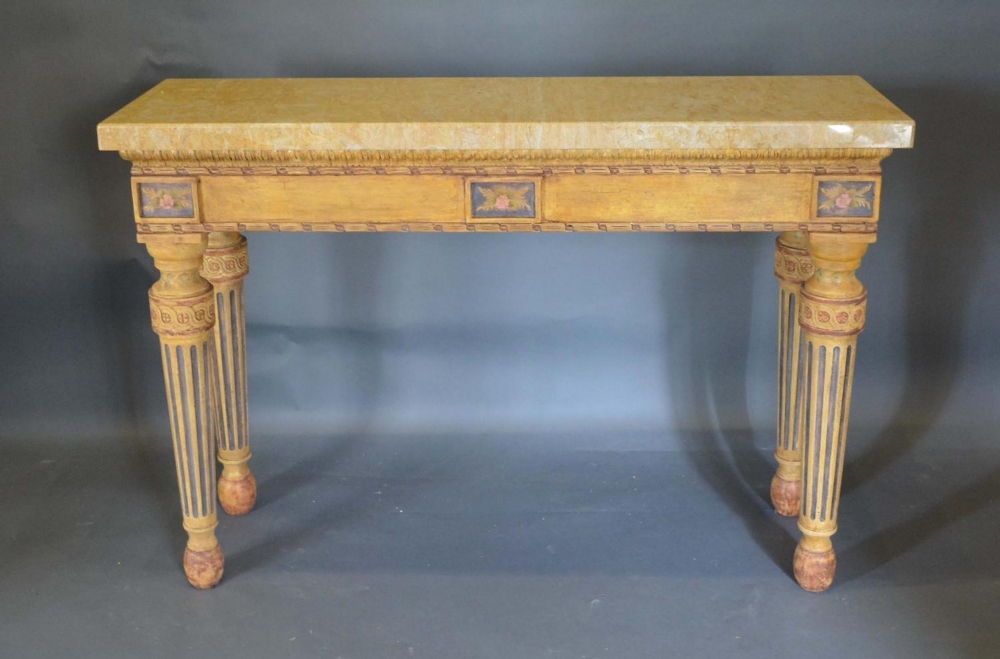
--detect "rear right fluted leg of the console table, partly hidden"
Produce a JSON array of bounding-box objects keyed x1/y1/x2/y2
[{"x1": 771, "y1": 231, "x2": 813, "y2": 517}]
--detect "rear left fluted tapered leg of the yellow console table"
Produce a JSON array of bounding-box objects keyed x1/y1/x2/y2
[{"x1": 201, "y1": 232, "x2": 257, "y2": 515}]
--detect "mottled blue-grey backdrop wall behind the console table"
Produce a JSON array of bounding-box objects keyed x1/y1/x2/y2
[{"x1": 0, "y1": 0, "x2": 1000, "y2": 462}]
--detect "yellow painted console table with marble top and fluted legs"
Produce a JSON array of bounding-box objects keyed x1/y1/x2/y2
[{"x1": 97, "y1": 76, "x2": 914, "y2": 591}]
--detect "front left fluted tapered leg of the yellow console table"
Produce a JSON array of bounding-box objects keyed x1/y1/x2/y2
[{"x1": 140, "y1": 235, "x2": 223, "y2": 588}]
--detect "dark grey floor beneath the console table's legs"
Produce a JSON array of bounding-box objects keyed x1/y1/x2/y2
[{"x1": 0, "y1": 433, "x2": 1000, "y2": 659}]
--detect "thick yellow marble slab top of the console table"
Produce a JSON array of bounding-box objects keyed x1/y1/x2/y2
[{"x1": 98, "y1": 76, "x2": 914, "y2": 151}]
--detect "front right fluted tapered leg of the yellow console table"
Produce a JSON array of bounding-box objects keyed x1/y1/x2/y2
[{"x1": 795, "y1": 234, "x2": 868, "y2": 591}]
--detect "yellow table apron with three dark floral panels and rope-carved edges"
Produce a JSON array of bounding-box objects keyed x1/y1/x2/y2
[{"x1": 133, "y1": 173, "x2": 881, "y2": 233}]
